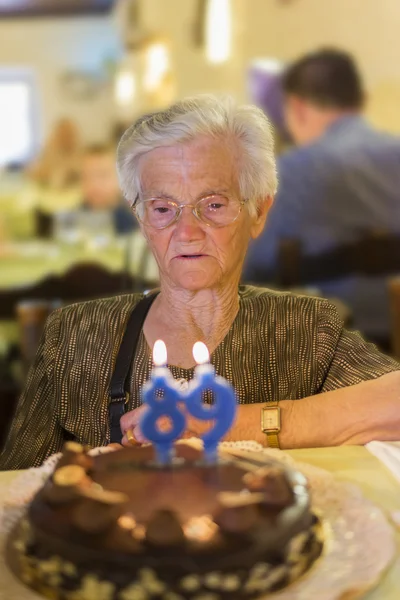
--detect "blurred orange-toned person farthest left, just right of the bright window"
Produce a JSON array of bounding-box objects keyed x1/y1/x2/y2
[{"x1": 27, "y1": 118, "x2": 82, "y2": 188}]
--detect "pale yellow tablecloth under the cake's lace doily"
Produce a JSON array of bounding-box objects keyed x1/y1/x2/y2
[{"x1": 0, "y1": 446, "x2": 400, "y2": 600}]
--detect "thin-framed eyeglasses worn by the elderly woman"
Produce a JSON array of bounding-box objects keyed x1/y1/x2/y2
[{"x1": 133, "y1": 194, "x2": 244, "y2": 229}]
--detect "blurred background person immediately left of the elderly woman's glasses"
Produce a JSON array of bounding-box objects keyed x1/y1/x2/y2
[{"x1": 82, "y1": 145, "x2": 136, "y2": 235}]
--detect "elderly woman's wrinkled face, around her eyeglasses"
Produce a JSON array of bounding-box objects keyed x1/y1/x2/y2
[{"x1": 139, "y1": 136, "x2": 268, "y2": 291}]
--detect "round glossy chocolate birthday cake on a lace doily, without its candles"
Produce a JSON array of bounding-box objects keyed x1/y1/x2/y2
[{"x1": 7, "y1": 442, "x2": 322, "y2": 600}]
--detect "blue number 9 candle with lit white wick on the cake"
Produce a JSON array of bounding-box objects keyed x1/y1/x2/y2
[{"x1": 186, "y1": 342, "x2": 237, "y2": 462}]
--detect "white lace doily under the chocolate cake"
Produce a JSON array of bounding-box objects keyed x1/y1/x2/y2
[{"x1": 0, "y1": 441, "x2": 395, "y2": 600}]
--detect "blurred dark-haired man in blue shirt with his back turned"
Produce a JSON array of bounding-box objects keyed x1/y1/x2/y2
[{"x1": 244, "y1": 49, "x2": 400, "y2": 346}]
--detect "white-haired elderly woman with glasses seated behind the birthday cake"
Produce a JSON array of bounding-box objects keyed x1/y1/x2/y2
[{"x1": 0, "y1": 97, "x2": 400, "y2": 469}]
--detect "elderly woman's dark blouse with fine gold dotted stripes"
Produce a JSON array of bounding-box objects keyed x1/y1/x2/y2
[{"x1": 0, "y1": 286, "x2": 400, "y2": 470}]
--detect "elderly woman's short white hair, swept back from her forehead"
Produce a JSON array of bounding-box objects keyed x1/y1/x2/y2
[{"x1": 117, "y1": 95, "x2": 277, "y2": 214}]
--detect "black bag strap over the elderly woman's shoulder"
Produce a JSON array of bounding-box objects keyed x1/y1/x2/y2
[{"x1": 108, "y1": 292, "x2": 158, "y2": 444}]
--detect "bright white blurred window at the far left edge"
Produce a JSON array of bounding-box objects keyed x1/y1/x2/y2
[{"x1": 0, "y1": 72, "x2": 34, "y2": 167}]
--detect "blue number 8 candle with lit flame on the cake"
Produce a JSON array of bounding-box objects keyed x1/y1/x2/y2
[{"x1": 140, "y1": 340, "x2": 186, "y2": 464}]
